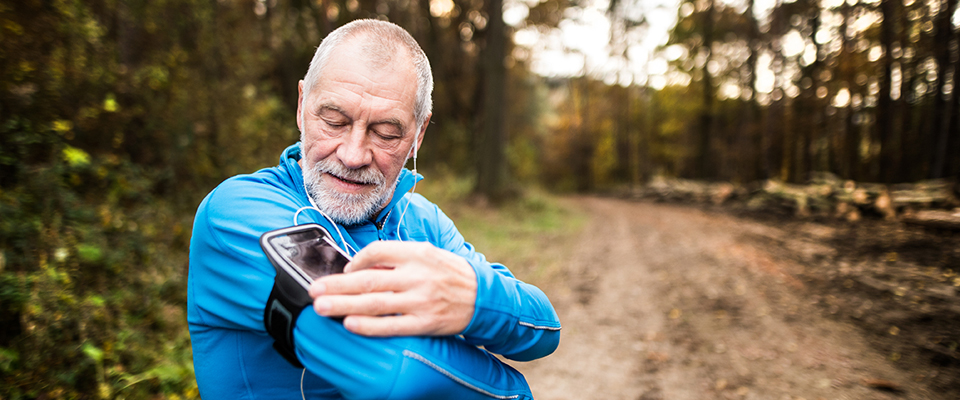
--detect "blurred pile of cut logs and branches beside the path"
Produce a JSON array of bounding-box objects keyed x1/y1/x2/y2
[{"x1": 628, "y1": 173, "x2": 960, "y2": 230}]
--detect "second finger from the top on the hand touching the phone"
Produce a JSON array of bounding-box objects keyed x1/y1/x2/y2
[{"x1": 308, "y1": 269, "x2": 409, "y2": 298}]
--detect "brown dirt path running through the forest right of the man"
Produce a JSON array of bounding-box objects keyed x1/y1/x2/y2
[{"x1": 513, "y1": 198, "x2": 943, "y2": 400}]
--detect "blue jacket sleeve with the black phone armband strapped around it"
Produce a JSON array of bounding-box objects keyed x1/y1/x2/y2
[{"x1": 188, "y1": 180, "x2": 532, "y2": 399}]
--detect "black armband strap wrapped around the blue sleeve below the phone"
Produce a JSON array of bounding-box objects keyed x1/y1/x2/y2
[{"x1": 263, "y1": 271, "x2": 313, "y2": 368}]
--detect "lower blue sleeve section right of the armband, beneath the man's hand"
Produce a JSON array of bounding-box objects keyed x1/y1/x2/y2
[{"x1": 294, "y1": 309, "x2": 532, "y2": 399}]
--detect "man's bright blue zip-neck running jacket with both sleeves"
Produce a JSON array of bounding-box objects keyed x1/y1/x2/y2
[{"x1": 187, "y1": 144, "x2": 560, "y2": 400}]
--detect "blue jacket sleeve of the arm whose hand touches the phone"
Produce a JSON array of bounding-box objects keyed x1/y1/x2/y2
[{"x1": 437, "y1": 208, "x2": 560, "y2": 361}]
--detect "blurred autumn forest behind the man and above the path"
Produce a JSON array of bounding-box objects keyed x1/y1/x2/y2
[{"x1": 0, "y1": 0, "x2": 960, "y2": 400}]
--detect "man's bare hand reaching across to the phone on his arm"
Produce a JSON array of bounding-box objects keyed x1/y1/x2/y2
[{"x1": 310, "y1": 241, "x2": 477, "y2": 336}]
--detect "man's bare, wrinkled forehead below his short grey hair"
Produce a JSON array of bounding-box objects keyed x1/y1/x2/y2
[{"x1": 310, "y1": 39, "x2": 417, "y2": 119}]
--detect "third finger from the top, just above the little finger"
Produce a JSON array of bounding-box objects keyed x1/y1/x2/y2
[{"x1": 313, "y1": 292, "x2": 410, "y2": 317}]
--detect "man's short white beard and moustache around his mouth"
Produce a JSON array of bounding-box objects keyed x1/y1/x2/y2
[{"x1": 303, "y1": 157, "x2": 397, "y2": 225}]
